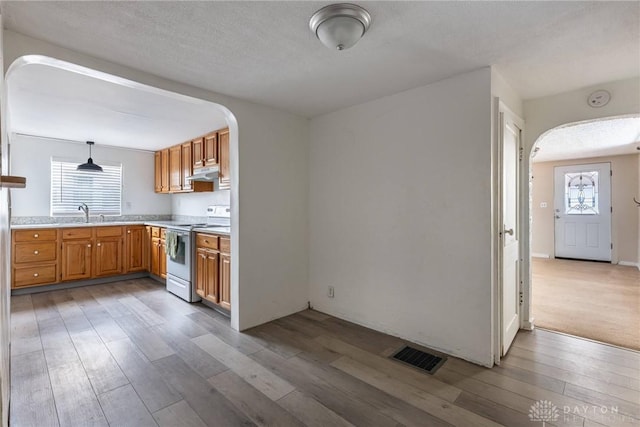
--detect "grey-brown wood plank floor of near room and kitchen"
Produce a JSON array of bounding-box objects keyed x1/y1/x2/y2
[{"x1": 10, "y1": 279, "x2": 640, "y2": 427}]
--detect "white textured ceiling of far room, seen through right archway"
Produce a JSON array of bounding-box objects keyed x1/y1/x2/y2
[{"x1": 533, "y1": 117, "x2": 640, "y2": 162}]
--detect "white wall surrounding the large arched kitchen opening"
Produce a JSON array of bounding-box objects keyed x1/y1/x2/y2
[{"x1": 4, "y1": 30, "x2": 309, "y2": 329}]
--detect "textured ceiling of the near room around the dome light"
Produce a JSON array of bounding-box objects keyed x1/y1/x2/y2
[{"x1": 1, "y1": 1, "x2": 640, "y2": 117}]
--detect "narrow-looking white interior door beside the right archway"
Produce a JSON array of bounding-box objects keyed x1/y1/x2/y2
[{"x1": 500, "y1": 112, "x2": 521, "y2": 355}]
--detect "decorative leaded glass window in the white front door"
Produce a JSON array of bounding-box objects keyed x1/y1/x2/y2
[{"x1": 564, "y1": 171, "x2": 600, "y2": 215}]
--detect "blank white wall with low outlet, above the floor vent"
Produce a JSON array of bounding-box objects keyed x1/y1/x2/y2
[{"x1": 309, "y1": 68, "x2": 493, "y2": 366}]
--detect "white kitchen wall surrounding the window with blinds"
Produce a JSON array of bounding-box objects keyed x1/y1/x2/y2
[{"x1": 10, "y1": 135, "x2": 171, "y2": 217}]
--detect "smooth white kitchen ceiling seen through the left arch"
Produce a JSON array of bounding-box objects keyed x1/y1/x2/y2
[{"x1": 7, "y1": 64, "x2": 226, "y2": 150}]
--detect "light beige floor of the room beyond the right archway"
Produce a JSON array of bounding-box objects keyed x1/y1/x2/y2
[{"x1": 532, "y1": 258, "x2": 640, "y2": 350}]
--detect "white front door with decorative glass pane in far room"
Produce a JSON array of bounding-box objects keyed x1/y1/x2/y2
[{"x1": 553, "y1": 163, "x2": 611, "y2": 261}]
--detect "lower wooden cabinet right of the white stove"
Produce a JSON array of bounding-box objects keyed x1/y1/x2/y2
[{"x1": 194, "y1": 233, "x2": 231, "y2": 310}]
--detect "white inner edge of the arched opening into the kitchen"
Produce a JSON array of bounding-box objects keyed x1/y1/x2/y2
[{"x1": 2, "y1": 55, "x2": 240, "y2": 330}]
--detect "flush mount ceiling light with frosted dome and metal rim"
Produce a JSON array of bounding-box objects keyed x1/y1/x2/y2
[{"x1": 309, "y1": 3, "x2": 371, "y2": 50}]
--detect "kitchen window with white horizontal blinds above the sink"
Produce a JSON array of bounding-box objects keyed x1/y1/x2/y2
[{"x1": 51, "y1": 158, "x2": 122, "y2": 216}]
